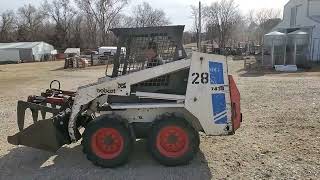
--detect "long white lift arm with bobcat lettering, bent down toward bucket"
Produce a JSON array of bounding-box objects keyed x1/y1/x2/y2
[{"x1": 68, "y1": 59, "x2": 191, "y2": 141}]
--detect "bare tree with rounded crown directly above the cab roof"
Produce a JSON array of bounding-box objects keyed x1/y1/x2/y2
[{"x1": 133, "y1": 2, "x2": 170, "y2": 27}]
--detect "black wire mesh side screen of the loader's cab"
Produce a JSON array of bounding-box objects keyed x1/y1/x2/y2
[{"x1": 107, "y1": 26, "x2": 186, "y2": 79}]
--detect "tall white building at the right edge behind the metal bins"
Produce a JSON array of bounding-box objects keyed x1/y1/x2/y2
[{"x1": 274, "y1": 0, "x2": 320, "y2": 62}]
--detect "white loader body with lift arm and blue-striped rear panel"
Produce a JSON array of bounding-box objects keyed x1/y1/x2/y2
[{"x1": 68, "y1": 52, "x2": 239, "y2": 141}]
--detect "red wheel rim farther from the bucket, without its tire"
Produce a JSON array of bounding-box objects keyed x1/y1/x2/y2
[{"x1": 156, "y1": 126, "x2": 189, "y2": 158}]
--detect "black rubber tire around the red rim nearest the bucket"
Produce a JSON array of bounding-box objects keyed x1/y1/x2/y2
[{"x1": 82, "y1": 116, "x2": 134, "y2": 168}]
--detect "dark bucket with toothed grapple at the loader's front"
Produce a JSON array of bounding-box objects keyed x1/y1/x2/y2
[{"x1": 8, "y1": 83, "x2": 75, "y2": 152}]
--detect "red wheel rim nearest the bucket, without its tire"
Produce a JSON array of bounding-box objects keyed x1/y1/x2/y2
[{"x1": 91, "y1": 128, "x2": 124, "y2": 159}]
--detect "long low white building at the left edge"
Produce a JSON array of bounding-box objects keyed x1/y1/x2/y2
[{"x1": 0, "y1": 42, "x2": 54, "y2": 62}]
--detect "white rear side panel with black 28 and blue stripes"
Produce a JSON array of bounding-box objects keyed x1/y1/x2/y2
[{"x1": 185, "y1": 52, "x2": 232, "y2": 135}]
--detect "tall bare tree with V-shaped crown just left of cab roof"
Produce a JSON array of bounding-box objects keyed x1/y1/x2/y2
[{"x1": 76, "y1": 0, "x2": 128, "y2": 45}]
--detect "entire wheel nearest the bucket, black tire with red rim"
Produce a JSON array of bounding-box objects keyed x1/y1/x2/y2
[{"x1": 82, "y1": 116, "x2": 134, "y2": 168}]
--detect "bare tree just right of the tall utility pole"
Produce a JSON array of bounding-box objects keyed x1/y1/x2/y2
[{"x1": 205, "y1": 0, "x2": 242, "y2": 47}]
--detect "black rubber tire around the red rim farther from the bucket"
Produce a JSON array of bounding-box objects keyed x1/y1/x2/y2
[{"x1": 148, "y1": 117, "x2": 200, "y2": 166}]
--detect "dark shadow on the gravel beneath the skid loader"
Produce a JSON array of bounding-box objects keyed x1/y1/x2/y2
[{"x1": 0, "y1": 140, "x2": 212, "y2": 180}]
